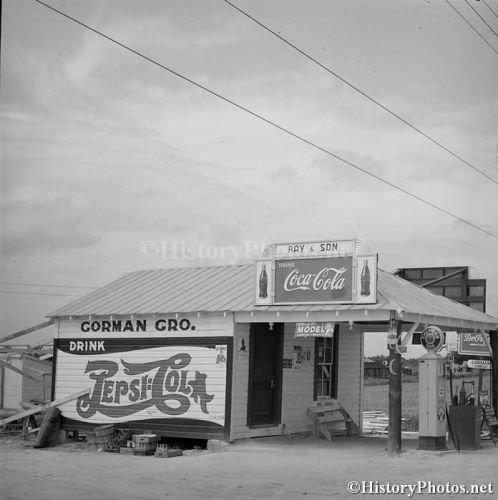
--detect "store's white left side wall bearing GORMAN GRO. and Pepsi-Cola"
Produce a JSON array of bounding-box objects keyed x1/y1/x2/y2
[{"x1": 54, "y1": 316, "x2": 233, "y2": 439}]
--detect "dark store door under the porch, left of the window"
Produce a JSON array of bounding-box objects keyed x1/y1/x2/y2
[{"x1": 247, "y1": 323, "x2": 284, "y2": 427}]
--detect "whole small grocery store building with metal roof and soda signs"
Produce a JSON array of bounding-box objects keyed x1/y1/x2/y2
[{"x1": 50, "y1": 242, "x2": 498, "y2": 441}]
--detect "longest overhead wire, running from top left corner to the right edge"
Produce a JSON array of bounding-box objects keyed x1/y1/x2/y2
[{"x1": 35, "y1": 0, "x2": 498, "y2": 239}]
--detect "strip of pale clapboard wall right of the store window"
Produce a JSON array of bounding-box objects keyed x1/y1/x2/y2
[{"x1": 337, "y1": 324, "x2": 363, "y2": 425}]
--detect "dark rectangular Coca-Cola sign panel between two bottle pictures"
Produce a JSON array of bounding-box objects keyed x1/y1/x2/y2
[{"x1": 274, "y1": 256, "x2": 353, "y2": 304}]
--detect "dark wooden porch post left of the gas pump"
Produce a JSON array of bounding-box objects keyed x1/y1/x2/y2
[{"x1": 387, "y1": 311, "x2": 401, "y2": 456}]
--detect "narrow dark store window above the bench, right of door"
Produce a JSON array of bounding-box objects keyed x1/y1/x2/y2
[{"x1": 314, "y1": 333, "x2": 337, "y2": 400}]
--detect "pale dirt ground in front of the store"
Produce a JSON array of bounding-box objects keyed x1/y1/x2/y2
[{"x1": 0, "y1": 436, "x2": 498, "y2": 500}]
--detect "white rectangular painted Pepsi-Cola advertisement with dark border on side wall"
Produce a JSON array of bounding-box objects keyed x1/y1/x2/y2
[{"x1": 55, "y1": 339, "x2": 227, "y2": 426}]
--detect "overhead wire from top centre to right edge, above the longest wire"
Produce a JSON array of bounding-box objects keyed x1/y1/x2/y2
[{"x1": 224, "y1": 0, "x2": 498, "y2": 184}]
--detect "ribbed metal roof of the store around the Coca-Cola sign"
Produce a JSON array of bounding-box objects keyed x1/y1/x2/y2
[{"x1": 49, "y1": 264, "x2": 498, "y2": 325}]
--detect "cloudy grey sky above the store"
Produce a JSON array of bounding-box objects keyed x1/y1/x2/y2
[{"x1": 0, "y1": 0, "x2": 498, "y2": 355}]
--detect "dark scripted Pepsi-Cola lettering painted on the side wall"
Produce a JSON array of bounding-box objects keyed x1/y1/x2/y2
[{"x1": 76, "y1": 353, "x2": 214, "y2": 419}]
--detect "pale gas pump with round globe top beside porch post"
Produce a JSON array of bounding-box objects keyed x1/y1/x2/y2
[{"x1": 418, "y1": 326, "x2": 447, "y2": 450}]
